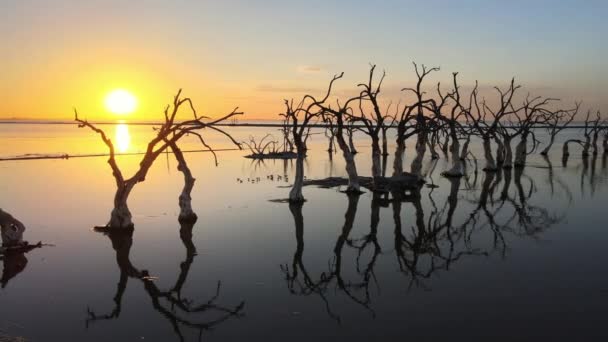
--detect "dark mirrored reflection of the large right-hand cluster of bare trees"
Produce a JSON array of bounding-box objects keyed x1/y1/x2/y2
[{"x1": 281, "y1": 165, "x2": 569, "y2": 322}]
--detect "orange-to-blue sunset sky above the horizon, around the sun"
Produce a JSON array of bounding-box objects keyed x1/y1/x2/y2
[{"x1": 0, "y1": 0, "x2": 608, "y2": 121}]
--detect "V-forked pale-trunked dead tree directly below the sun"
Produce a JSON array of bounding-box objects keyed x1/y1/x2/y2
[{"x1": 74, "y1": 89, "x2": 243, "y2": 228}]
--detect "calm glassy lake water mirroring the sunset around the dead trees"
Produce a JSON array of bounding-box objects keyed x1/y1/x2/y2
[{"x1": 0, "y1": 125, "x2": 608, "y2": 341}]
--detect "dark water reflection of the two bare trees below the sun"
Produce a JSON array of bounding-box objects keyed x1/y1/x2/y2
[{"x1": 86, "y1": 223, "x2": 244, "y2": 341}]
